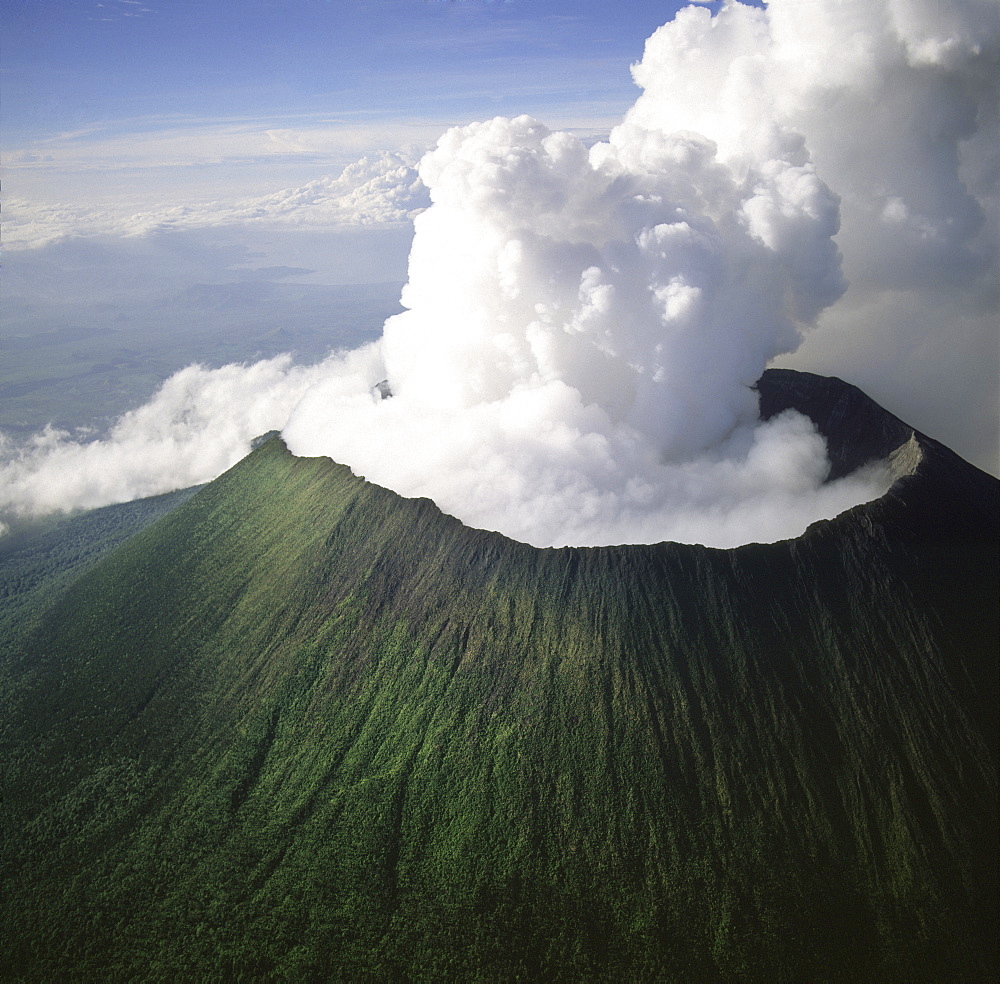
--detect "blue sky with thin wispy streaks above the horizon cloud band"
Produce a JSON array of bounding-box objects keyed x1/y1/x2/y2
[{"x1": 0, "y1": 0, "x2": 712, "y2": 201}]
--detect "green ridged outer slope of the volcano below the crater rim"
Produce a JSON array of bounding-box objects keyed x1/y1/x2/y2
[{"x1": 0, "y1": 372, "x2": 998, "y2": 981}]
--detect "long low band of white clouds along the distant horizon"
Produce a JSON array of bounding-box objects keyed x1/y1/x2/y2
[{"x1": 4, "y1": 152, "x2": 429, "y2": 250}]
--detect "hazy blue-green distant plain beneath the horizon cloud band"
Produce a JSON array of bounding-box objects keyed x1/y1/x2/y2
[{"x1": 0, "y1": 235, "x2": 405, "y2": 443}]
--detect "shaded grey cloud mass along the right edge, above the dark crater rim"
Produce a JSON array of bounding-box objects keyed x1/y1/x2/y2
[{"x1": 770, "y1": 0, "x2": 1000, "y2": 473}]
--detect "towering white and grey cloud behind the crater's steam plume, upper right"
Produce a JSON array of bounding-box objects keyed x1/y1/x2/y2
[{"x1": 604, "y1": 0, "x2": 1000, "y2": 472}]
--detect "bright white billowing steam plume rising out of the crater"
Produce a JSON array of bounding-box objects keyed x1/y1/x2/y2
[{"x1": 292, "y1": 3, "x2": 968, "y2": 546}]
